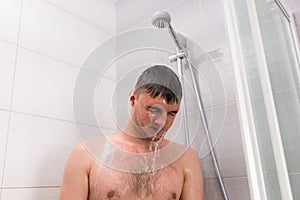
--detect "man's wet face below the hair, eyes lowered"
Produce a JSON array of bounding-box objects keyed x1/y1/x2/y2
[{"x1": 131, "y1": 93, "x2": 180, "y2": 141}]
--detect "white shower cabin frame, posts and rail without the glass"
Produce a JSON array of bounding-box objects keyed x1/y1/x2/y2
[{"x1": 223, "y1": 0, "x2": 299, "y2": 200}]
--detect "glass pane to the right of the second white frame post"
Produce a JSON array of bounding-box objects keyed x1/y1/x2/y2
[{"x1": 256, "y1": 0, "x2": 300, "y2": 199}]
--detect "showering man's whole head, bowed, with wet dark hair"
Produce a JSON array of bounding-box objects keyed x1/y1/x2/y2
[{"x1": 130, "y1": 65, "x2": 182, "y2": 140}]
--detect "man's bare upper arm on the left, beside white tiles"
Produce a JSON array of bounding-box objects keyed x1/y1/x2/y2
[{"x1": 60, "y1": 145, "x2": 89, "y2": 200}]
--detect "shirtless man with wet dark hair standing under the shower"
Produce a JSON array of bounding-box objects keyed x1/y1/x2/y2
[{"x1": 60, "y1": 65, "x2": 204, "y2": 200}]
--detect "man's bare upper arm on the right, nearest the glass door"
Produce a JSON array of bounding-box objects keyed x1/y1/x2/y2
[{"x1": 181, "y1": 148, "x2": 204, "y2": 200}]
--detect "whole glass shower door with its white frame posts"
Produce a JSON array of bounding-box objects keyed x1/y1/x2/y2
[{"x1": 223, "y1": 0, "x2": 300, "y2": 200}]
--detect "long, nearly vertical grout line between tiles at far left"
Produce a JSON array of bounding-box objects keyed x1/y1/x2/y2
[{"x1": 0, "y1": 0, "x2": 24, "y2": 200}]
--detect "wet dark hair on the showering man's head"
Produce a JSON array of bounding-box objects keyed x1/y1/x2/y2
[{"x1": 135, "y1": 65, "x2": 182, "y2": 104}]
